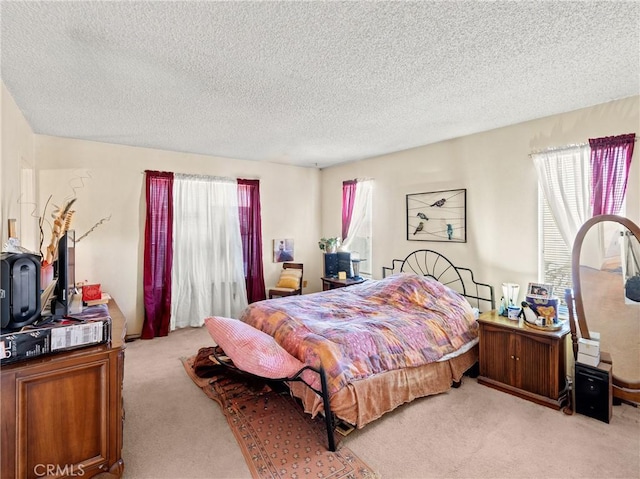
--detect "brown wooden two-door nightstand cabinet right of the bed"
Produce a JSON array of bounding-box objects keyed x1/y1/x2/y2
[{"x1": 478, "y1": 311, "x2": 569, "y2": 409}]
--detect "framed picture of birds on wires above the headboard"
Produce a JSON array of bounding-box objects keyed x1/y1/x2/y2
[{"x1": 407, "y1": 189, "x2": 467, "y2": 243}]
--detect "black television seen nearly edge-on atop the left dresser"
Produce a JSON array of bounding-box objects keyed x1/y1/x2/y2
[{"x1": 51, "y1": 230, "x2": 76, "y2": 317}]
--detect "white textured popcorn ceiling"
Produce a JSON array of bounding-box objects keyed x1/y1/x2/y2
[{"x1": 0, "y1": 0, "x2": 640, "y2": 168}]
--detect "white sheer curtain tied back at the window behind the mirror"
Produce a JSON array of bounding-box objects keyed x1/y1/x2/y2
[{"x1": 531, "y1": 145, "x2": 591, "y2": 251}]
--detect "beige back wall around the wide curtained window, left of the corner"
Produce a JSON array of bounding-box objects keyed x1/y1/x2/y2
[{"x1": 35, "y1": 135, "x2": 321, "y2": 334}]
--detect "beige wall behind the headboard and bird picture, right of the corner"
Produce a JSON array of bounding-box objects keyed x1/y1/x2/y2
[{"x1": 321, "y1": 96, "x2": 640, "y2": 299}]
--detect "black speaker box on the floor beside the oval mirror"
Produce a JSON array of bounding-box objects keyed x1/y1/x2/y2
[{"x1": 575, "y1": 363, "x2": 613, "y2": 423}]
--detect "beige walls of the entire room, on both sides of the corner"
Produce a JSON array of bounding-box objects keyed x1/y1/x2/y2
[{"x1": 0, "y1": 79, "x2": 640, "y2": 334}]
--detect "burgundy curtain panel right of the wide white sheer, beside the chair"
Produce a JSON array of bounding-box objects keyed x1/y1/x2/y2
[{"x1": 238, "y1": 179, "x2": 267, "y2": 303}]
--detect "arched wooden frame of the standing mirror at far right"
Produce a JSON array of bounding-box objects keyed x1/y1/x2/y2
[{"x1": 570, "y1": 215, "x2": 640, "y2": 403}]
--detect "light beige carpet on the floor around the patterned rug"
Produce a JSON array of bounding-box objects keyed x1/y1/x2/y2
[{"x1": 123, "y1": 328, "x2": 640, "y2": 479}]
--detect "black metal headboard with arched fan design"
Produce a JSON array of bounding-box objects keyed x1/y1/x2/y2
[{"x1": 382, "y1": 249, "x2": 496, "y2": 311}]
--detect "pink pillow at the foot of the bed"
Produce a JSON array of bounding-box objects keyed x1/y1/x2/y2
[{"x1": 204, "y1": 316, "x2": 304, "y2": 379}]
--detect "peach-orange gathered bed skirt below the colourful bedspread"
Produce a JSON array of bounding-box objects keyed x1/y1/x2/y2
[{"x1": 289, "y1": 344, "x2": 478, "y2": 428}]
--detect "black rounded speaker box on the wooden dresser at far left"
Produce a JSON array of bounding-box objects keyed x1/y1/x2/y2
[{"x1": 0, "y1": 253, "x2": 41, "y2": 330}]
